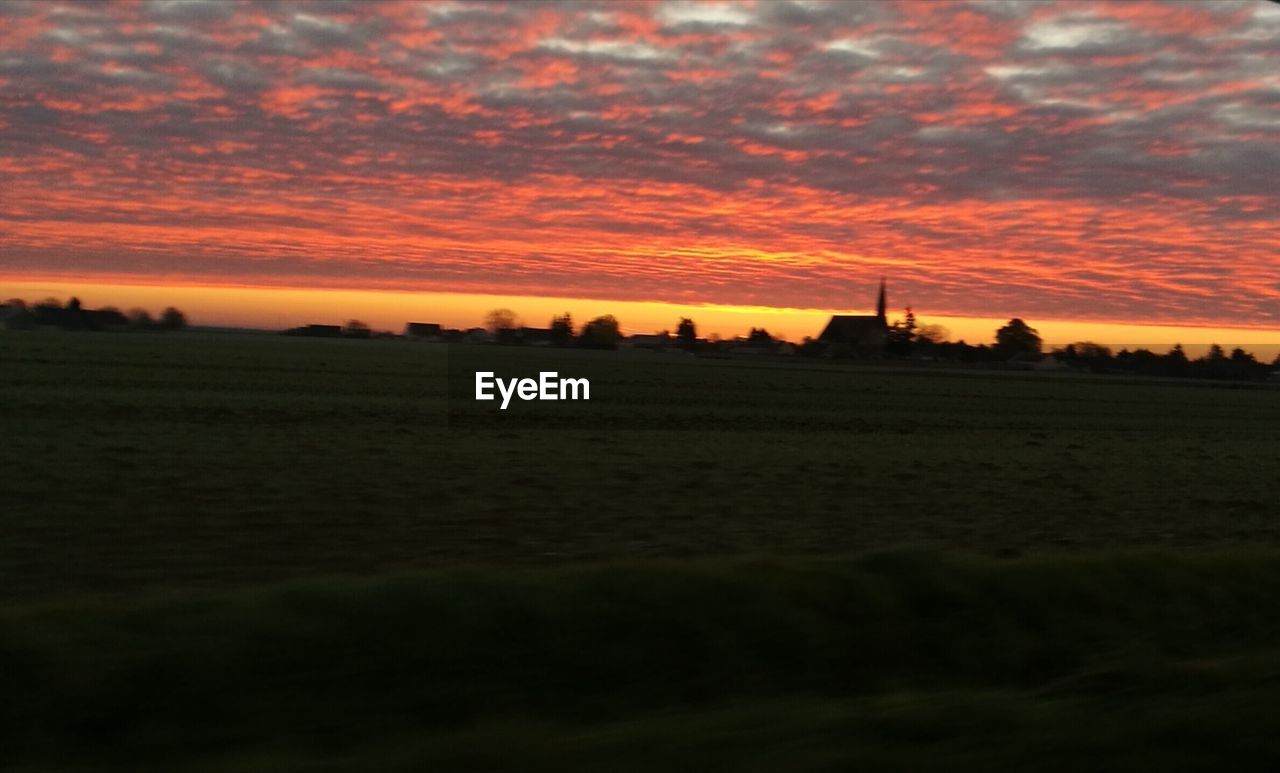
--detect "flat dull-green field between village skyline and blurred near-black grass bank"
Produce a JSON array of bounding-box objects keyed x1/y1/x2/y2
[{"x1": 0, "y1": 333, "x2": 1280, "y2": 604}]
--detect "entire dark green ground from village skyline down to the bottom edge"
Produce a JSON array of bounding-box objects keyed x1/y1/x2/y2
[{"x1": 0, "y1": 333, "x2": 1280, "y2": 770}]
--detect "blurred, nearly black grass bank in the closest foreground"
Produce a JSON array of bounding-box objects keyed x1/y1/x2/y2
[{"x1": 0, "y1": 552, "x2": 1280, "y2": 772}]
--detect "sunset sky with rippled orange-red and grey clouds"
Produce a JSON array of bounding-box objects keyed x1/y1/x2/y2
[{"x1": 0, "y1": 0, "x2": 1280, "y2": 342}]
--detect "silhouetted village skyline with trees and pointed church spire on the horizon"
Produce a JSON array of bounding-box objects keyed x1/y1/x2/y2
[{"x1": 10, "y1": 286, "x2": 1280, "y2": 383}]
